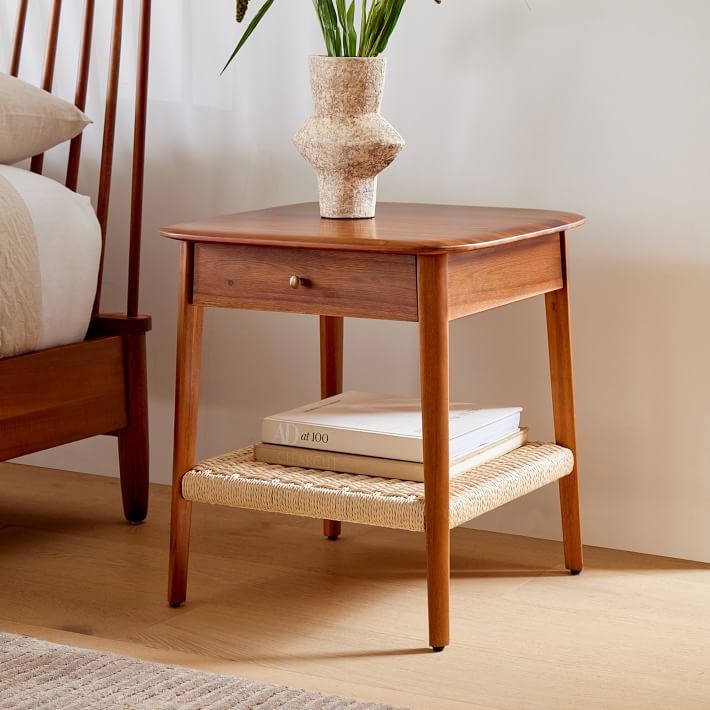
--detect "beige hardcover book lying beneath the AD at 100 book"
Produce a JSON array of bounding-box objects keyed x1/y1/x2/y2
[{"x1": 254, "y1": 429, "x2": 528, "y2": 482}]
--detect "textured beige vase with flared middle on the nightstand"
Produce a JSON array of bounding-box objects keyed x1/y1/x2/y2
[{"x1": 293, "y1": 57, "x2": 404, "y2": 219}]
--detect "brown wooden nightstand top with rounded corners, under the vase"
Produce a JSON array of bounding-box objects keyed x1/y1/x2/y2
[{"x1": 161, "y1": 202, "x2": 584, "y2": 254}]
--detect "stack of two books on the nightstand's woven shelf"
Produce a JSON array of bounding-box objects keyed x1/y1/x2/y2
[{"x1": 254, "y1": 392, "x2": 527, "y2": 481}]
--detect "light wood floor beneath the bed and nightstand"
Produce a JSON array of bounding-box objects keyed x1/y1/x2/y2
[{"x1": 0, "y1": 464, "x2": 710, "y2": 709}]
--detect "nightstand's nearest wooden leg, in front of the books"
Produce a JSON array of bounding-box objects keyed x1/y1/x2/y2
[{"x1": 417, "y1": 256, "x2": 450, "y2": 651}]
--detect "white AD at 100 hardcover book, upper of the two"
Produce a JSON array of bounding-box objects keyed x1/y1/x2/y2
[{"x1": 261, "y1": 392, "x2": 522, "y2": 463}]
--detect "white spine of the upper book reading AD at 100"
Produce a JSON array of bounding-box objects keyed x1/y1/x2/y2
[{"x1": 261, "y1": 417, "x2": 423, "y2": 463}]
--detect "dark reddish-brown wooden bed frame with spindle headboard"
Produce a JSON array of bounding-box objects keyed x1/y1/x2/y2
[{"x1": 0, "y1": 0, "x2": 151, "y2": 523}]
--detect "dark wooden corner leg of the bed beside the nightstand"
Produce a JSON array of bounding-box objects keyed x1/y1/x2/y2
[{"x1": 118, "y1": 333, "x2": 150, "y2": 523}]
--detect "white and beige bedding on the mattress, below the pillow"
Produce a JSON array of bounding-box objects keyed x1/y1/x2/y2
[{"x1": 0, "y1": 165, "x2": 101, "y2": 357}]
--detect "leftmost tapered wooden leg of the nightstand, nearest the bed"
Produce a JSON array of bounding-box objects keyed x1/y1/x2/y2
[{"x1": 168, "y1": 243, "x2": 202, "y2": 606}]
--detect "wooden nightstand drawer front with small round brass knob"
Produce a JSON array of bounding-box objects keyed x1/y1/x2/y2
[{"x1": 193, "y1": 244, "x2": 417, "y2": 321}]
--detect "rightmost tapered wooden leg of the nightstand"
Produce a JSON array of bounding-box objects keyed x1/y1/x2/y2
[{"x1": 545, "y1": 234, "x2": 584, "y2": 574}]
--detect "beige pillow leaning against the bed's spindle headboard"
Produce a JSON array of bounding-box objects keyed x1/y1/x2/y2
[{"x1": 0, "y1": 74, "x2": 91, "y2": 165}]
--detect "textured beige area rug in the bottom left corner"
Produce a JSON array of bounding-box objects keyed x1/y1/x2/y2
[{"x1": 0, "y1": 634, "x2": 400, "y2": 710}]
